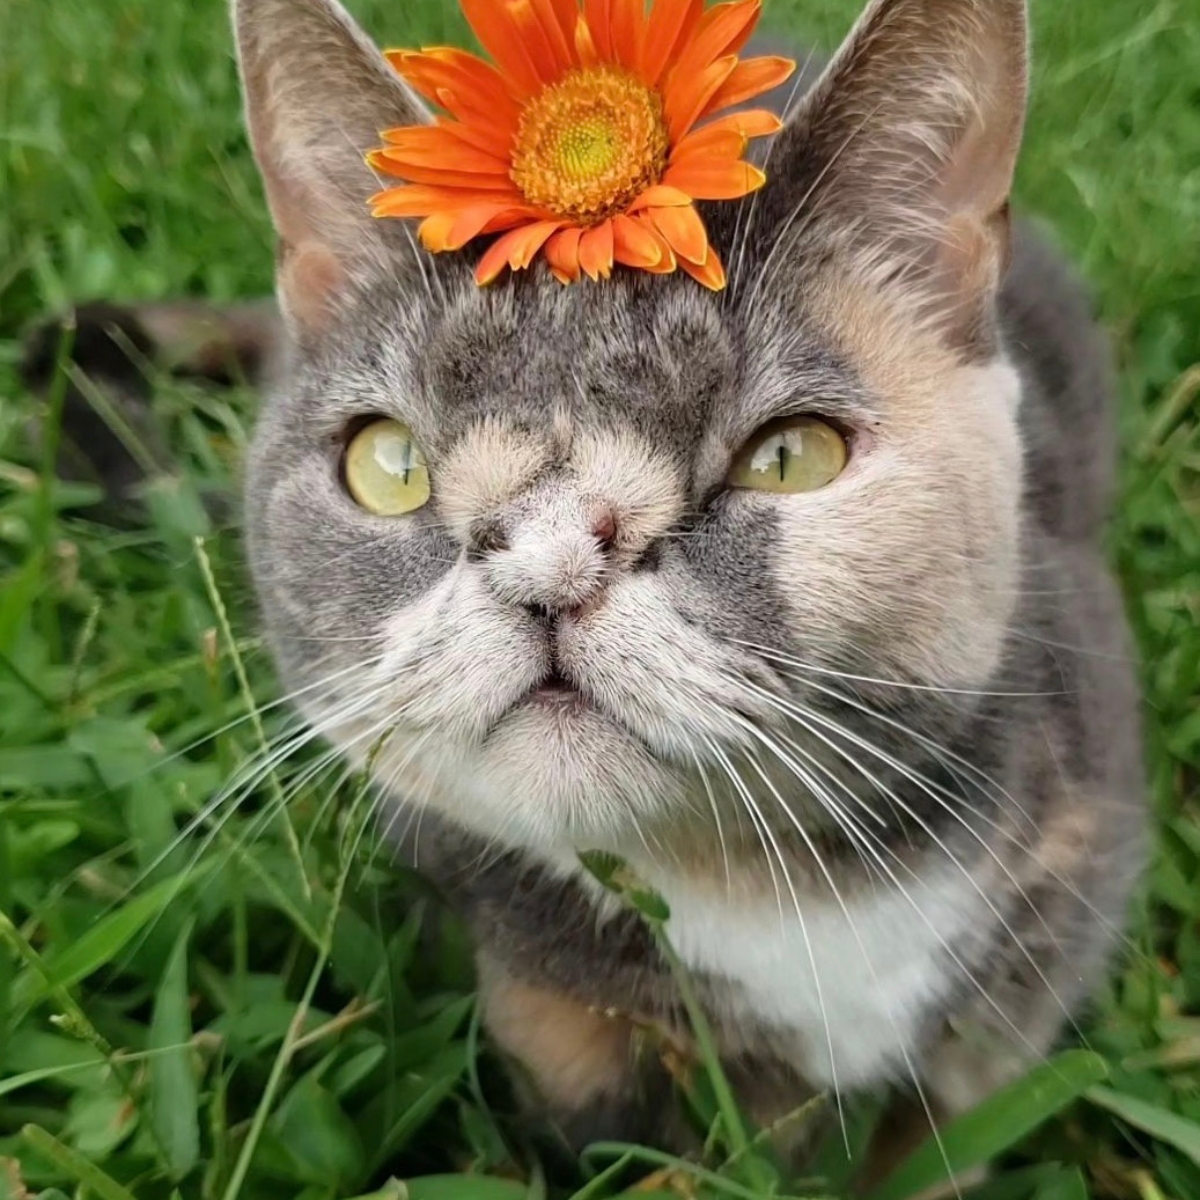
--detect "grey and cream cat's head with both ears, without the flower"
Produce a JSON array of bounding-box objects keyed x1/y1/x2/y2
[{"x1": 235, "y1": 0, "x2": 1026, "y2": 851}]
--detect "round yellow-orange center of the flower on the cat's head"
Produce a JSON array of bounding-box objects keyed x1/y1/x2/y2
[{"x1": 512, "y1": 66, "x2": 667, "y2": 224}]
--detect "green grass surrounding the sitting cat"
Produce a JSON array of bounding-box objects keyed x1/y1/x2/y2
[{"x1": 0, "y1": 0, "x2": 1200, "y2": 1200}]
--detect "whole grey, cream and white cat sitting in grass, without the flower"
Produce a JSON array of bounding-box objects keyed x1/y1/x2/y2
[{"x1": 35, "y1": 0, "x2": 1145, "y2": 1185}]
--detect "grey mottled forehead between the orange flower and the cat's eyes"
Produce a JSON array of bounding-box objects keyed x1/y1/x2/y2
[{"x1": 300, "y1": 264, "x2": 876, "y2": 462}]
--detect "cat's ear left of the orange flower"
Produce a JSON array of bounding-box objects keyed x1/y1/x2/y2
[{"x1": 233, "y1": 0, "x2": 430, "y2": 328}]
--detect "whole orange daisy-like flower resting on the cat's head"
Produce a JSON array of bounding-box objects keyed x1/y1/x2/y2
[{"x1": 367, "y1": 0, "x2": 796, "y2": 290}]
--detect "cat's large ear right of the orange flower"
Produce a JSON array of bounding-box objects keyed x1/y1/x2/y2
[{"x1": 760, "y1": 0, "x2": 1028, "y2": 346}]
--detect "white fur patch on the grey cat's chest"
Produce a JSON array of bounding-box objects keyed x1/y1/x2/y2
[{"x1": 648, "y1": 866, "x2": 986, "y2": 1088}]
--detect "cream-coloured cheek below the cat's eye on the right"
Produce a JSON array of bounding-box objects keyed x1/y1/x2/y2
[{"x1": 773, "y1": 431, "x2": 1016, "y2": 686}]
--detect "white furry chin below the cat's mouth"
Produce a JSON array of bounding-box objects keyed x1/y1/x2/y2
[{"x1": 380, "y1": 688, "x2": 683, "y2": 852}]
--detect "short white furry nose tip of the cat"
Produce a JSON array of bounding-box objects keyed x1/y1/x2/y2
[{"x1": 478, "y1": 503, "x2": 620, "y2": 619}]
